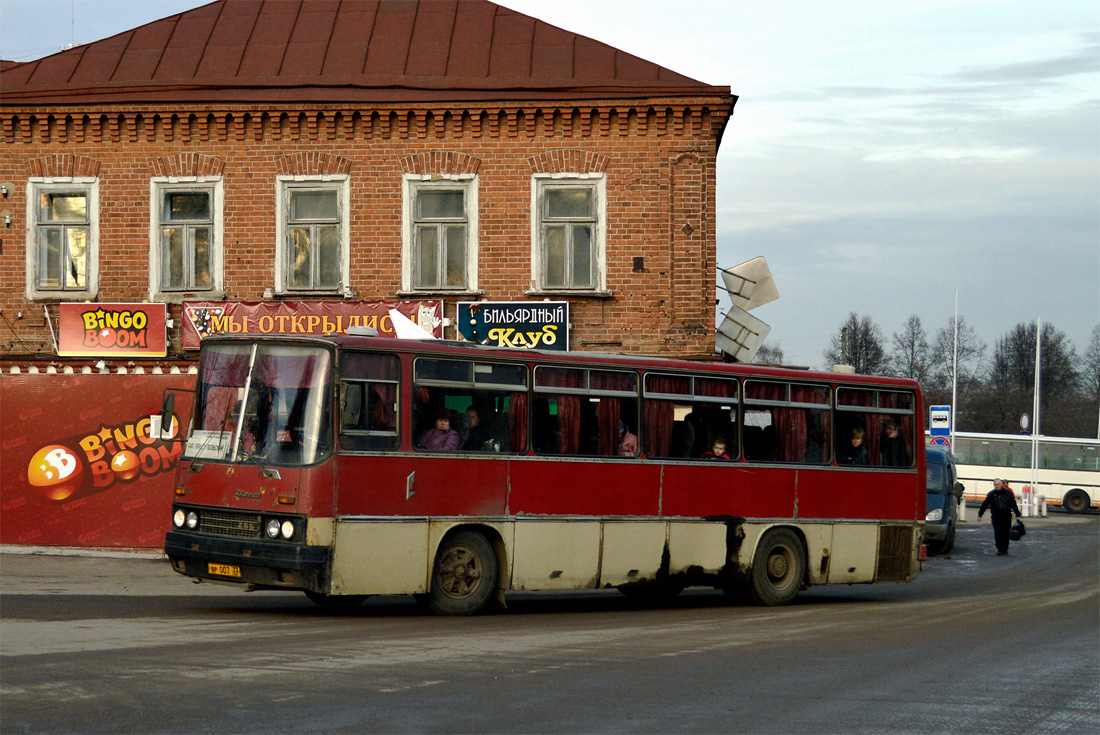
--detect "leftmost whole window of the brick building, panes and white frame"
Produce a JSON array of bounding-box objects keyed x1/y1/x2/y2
[{"x1": 26, "y1": 178, "x2": 99, "y2": 299}]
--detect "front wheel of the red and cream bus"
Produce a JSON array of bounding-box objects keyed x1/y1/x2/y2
[{"x1": 428, "y1": 530, "x2": 497, "y2": 615}]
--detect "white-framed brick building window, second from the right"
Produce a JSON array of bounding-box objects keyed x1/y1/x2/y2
[{"x1": 402, "y1": 175, "x2": 477, "y2": 293}]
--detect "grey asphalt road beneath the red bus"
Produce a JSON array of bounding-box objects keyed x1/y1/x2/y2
[{"x1": 0, "y1": 514, "x2": 1100, "y2": 735}]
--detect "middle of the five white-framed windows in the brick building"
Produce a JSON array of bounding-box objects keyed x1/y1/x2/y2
[{"x1": 276, "y1": 177, "x2": 348, "y2": 293}]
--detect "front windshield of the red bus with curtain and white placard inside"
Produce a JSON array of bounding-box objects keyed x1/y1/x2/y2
[{"x1": 184, "y1": 343, "x2": 332, "y2": 465}]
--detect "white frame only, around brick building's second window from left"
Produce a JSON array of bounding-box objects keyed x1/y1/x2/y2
[{"x1": 149, "y1": 176, "x2": 226, "y2": 304}]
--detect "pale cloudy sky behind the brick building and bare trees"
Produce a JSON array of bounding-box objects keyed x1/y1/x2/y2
[{"x1": 0, "y1": 0, "x2": 1100, "y2": 365}]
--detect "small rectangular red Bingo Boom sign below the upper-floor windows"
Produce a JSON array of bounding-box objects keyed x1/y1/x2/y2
[{"x1": 57, "y1": 304, "x2": 168, "y2": 358}]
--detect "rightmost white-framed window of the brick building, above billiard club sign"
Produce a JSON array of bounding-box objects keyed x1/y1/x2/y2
[{"x1": 531, "y1": 175, "x2": 606, "y2": 292}]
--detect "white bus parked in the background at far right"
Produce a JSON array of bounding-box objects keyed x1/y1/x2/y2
[{"x1": 937, "y1": 431, "x2": 1100, "y2": 513}]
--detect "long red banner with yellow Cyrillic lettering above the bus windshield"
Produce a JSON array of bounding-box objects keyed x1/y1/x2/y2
[{"x1": 180, "y1": 301, "x2": 443, "y2": 350}]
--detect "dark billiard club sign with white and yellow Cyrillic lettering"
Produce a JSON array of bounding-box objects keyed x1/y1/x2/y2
[{"x1": 458, "y1": 301, "x2": 569, "y2": 351}]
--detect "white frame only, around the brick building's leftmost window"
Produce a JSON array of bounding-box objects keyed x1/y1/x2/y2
[{"x1": 25, "y1": 176, "x2": 99, "y2": 301}]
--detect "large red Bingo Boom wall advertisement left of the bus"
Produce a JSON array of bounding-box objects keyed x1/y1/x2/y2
[{"x1": 0, "y1": 374, "x2": 195, "y2": 548}]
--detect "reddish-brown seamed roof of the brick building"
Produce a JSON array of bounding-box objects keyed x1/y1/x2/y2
[{"x1": 0, "y1": 0, "x2": 729, "y2": 106}]
